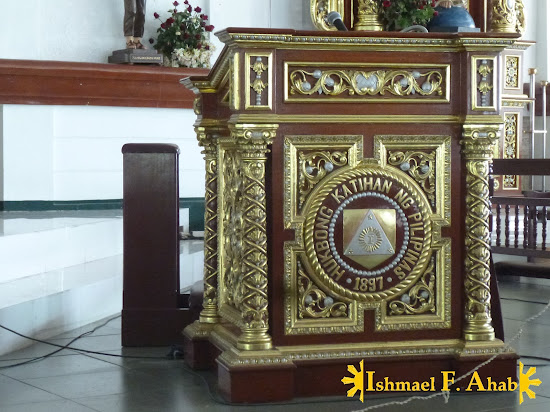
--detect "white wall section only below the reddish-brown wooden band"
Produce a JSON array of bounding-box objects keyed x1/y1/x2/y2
[{"x1": 3, "y1": 105, "x2": 204, "y2": 201}]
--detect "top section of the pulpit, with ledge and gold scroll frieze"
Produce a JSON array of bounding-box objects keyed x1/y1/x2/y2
[{"x1": 181, "y1": 28, "x2": 521, "y2": 133}]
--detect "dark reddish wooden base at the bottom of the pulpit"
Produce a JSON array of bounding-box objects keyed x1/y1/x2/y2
[{"x1": 185, "y1": 334, "x2": 518, "y2": 406}]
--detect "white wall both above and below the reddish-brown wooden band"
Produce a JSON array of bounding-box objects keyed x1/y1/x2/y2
[{"x1": 0, "y1": 0, "x2": 313, "y2": 201}]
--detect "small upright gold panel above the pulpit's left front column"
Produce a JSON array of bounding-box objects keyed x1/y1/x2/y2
[{"x1": 244, "y1": 52, "x2": 273, "y2": 110}]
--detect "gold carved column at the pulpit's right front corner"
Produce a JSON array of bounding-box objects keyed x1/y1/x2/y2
[{"x1": 461, "y1": 124, "x2": 500, "y2": 341}]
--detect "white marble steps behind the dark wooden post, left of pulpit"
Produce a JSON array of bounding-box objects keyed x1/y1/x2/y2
[{"x1": 0, "y1": 212, "x2": 204, "y2": 355}]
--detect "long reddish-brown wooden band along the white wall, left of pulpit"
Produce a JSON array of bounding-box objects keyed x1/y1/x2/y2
[{"x1": 0, "y1": 59, "x2": 209, "y2": 109}]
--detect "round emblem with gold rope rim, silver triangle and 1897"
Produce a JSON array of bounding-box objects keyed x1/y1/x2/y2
[{"x1": 304, "y1": 164, "x2": 432, "y2": 301}]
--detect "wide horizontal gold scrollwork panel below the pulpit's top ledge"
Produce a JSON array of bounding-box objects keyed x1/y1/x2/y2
[{"x1": 284, "y1": 62, "x2": 451, "y2": 103}]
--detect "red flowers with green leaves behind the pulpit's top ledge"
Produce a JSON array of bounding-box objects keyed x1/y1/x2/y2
[{"x1": 379, "y1": 0, "x2": 438, "y2": 31}]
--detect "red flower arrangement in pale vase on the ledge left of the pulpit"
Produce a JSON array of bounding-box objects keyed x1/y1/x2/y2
[{"x1": 149, "y1": 0, "x2": 214, "y2": 67}]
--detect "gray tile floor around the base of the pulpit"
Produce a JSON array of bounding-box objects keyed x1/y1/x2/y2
[{"x1": 0, "y1": 282, "x2": 550, "y2": 412}]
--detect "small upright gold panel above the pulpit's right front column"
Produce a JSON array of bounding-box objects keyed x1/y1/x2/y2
[{"x1": 471, "y1": 56, "x2": 498, "y2": 111}]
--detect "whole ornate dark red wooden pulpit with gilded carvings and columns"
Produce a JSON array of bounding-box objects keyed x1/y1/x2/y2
[{"x1": 184, "y1": 29, "x2": 517, "y2": 402}]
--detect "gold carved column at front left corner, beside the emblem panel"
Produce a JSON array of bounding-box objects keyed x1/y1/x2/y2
[{"x1": 229, "y1": 124, "x2": 278, "y2": 350}]
